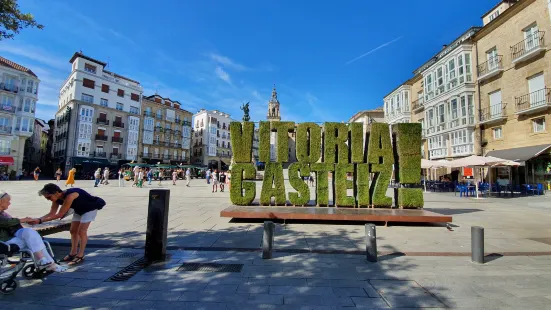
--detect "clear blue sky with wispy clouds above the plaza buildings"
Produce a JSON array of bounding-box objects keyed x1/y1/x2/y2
[{"x1": 0, "y1": 0, "x2": 498, "y2": 122}]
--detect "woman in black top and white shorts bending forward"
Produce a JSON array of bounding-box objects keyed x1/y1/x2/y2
[{"x1": 35, "y1": 183, "x2": 105, "y2": 265}]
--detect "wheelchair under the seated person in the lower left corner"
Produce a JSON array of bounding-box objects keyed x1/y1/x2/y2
[{"x1": 0, "y1": 240, "x2": 57, "y2": 295}]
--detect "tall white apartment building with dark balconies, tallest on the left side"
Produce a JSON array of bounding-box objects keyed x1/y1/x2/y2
[{"x1": 53, "y1": 52, "x2": 143, "y2": 173}]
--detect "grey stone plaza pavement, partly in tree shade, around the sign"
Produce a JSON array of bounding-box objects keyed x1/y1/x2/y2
[{"x1": 0, "y1": 180, "x2": 551, "y2": 310}]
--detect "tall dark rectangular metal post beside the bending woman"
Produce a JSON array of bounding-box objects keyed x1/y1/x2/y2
[{"x1": 144, "y1": 189, "x2": 170, "y2": 262}]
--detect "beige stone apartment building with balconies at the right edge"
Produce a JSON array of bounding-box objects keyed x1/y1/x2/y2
[{"x1": 474, "y1": 0, "x2": 551, "y2": 184}]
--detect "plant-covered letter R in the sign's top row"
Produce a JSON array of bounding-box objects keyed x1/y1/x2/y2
[{"x1": 323, "y1": 123, "x2": 348, "y2": 164}]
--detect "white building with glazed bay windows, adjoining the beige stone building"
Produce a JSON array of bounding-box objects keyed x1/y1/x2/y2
[{"x1": 416, "y1": 27, "x2": 480, "y2": 159}]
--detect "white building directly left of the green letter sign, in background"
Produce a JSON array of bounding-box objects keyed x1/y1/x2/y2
[{"x1": 192, "y1": 109, "x2": 234, "y2": 169}]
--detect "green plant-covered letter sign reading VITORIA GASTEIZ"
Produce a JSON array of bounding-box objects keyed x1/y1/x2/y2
[{"x1": 230, "y1": 121, "x2": 424, "y2": 209}]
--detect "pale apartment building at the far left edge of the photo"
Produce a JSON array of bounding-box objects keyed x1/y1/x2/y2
[{"x1": 0, "y1": 57, "x2": 40, "y2": 173}]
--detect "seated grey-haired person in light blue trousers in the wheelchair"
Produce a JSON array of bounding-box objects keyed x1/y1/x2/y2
[{"x1": 0, "y1": 191, "x2": 67, "y2": 272}]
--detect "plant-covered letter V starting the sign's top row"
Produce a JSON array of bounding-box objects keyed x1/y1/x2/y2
[{"x1": 230, "y1": 122, "x2": 254, "y2": 163}]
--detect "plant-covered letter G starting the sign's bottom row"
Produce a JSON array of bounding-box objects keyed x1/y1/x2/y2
[{"x1": 230, "y1": 163, "x2": 256, "y2": 206}]
